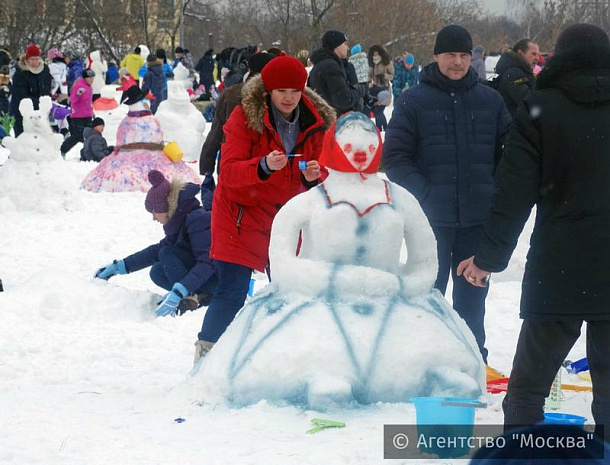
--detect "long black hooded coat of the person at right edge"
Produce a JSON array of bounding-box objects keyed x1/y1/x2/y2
[{"x1": 475, "y1": 48, "x2": 610, "y2": 320}]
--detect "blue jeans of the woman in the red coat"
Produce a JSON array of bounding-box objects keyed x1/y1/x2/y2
[{"x1": 197, "y1": 261, "x2": 252, "y2": 342}]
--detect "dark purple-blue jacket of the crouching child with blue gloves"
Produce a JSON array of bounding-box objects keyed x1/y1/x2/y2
[{"x1": 125, "y1": 183, "x2": 216, "y2": 292}]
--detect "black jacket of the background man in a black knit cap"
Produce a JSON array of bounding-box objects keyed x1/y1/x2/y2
[{"x1": 308, "y1": 47, "x2": 358, "y2": 116}]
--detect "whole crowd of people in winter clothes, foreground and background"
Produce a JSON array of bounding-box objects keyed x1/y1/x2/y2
[{"x1": 0, "y1": 24, "x2": 610, "y2": 446}]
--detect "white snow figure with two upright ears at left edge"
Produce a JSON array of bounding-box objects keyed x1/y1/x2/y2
[{"x1": 0, "y1": 96, "x2": 80, "y2": 213}]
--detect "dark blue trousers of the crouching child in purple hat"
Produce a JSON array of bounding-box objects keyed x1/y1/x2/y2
[{"x1": 150, "y1": 245, "x2": 218, "y2": 295}]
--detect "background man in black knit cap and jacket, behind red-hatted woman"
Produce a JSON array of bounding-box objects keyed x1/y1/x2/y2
[{"x1": 308, "y1": 30, "x2": 366, "y2": 116}]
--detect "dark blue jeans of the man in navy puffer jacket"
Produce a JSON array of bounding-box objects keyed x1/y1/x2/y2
[{"x1": 432, "y1": 225, "x2": 489, "y2": 363}]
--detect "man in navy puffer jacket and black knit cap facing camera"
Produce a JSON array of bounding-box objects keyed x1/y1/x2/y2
[{"x1": 382, "y1": 26, "x2": 510, "y2": 361}]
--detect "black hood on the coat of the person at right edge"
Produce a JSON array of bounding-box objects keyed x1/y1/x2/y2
[{"x1": 536, "y1": 47, "x2": 610, "y2": 103}]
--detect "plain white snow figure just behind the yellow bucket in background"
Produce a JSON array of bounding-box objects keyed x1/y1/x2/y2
[{"x1": 155, "y1": 82, "x2": 205, "y2": 161}]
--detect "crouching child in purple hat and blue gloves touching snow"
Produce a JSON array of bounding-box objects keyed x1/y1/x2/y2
[{"x1": 95, "y1": 170, "x2": 218, "y2": 316}]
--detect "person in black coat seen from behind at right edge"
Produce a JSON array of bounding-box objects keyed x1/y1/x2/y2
[{"x1": 458, "y1": 24, "x2": 610, "y2": 440}]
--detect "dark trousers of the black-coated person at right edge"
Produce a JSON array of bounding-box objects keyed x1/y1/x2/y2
[{"x1": 502, "y1": 319, "x2": 610, "y2": 440}]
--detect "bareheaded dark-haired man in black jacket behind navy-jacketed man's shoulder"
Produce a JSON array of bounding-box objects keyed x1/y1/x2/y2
[{"x1": 496, "y1": 39, "x2": 540, "y2": 118}]
